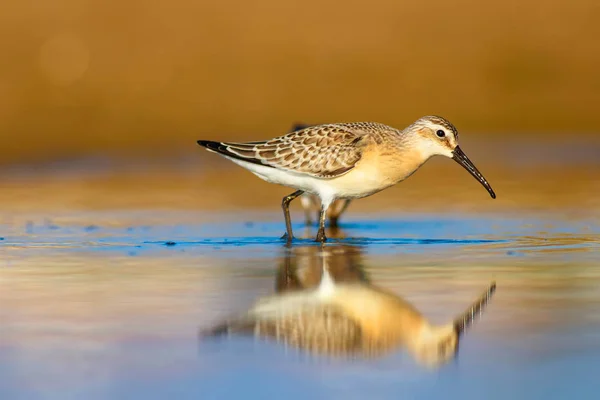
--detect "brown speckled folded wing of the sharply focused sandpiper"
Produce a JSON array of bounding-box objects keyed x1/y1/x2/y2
[{"x1": 221, "y1": 124, "x2": 368, "y2": 178}]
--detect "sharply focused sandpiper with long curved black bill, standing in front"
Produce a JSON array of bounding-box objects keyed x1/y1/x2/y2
[{"x1": 198, "y1": 116, "x2": 496, "y2": 242}]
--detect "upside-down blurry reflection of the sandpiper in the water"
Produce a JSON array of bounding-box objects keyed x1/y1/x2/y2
[{"x1": 200, "y1": 245, "x2": 496, "y2": 367}]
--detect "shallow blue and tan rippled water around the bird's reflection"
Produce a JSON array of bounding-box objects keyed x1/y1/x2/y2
[{"x1": 0, "y1": 210, "x2": 600, "y2": 399}]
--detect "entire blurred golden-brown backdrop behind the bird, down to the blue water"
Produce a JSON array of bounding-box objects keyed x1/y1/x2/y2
[{"x1": 0, "y1": 0, "x2": 600, "y2": 215}]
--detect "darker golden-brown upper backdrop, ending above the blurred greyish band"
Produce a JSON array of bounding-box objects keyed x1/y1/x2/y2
[{"x1": 0, "y1": 0, "x2": 600, "y2": 164}]
